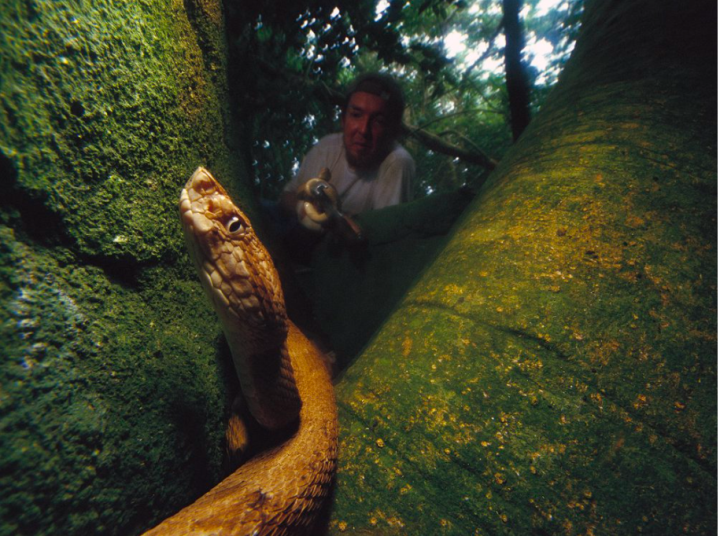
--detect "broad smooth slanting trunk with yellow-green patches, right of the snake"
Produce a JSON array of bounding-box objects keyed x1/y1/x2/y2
[{"x1": 330, "y1": 0, "x2": 717, "y2": 535}]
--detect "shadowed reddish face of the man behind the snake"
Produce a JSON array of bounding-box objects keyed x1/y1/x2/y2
[{"x1": 342, "y1": 91, "x2": 393, "y2": 169}]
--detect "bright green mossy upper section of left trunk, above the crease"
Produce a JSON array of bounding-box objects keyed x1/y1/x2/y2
[{"x1": 0, "y1": 1, "x2": 252, "y2": 262}]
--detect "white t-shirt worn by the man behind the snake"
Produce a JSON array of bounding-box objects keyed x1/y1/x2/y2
[{"x1": 285, "y1": 133, "x2": 415, "y2": 214}]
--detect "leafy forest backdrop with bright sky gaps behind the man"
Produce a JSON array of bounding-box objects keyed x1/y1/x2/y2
[{"x1": 226, "y1": 0, "x2": 583, "y2": 199}]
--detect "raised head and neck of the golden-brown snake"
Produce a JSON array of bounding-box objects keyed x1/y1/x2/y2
[{"x1": 180, "y1": 167, "x2": 300, "y2": 429}]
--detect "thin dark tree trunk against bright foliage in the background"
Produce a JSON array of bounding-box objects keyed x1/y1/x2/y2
[{"x1": 503, "y1": 0, "x2": 530, "y2": 141}]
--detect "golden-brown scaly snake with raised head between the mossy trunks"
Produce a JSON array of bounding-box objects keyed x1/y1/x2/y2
[{"x1": 145, "y1": 167, "x2": 338, "y2": 536}]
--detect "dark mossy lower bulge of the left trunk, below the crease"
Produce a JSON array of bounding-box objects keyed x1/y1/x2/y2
[{"x1": 0, "y1": 228, "x2": 226, "y2": 534}]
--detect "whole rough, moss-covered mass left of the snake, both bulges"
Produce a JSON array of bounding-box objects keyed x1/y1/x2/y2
[{"x1": 0, "y1": 0, "x2": 250, "y2": 535}]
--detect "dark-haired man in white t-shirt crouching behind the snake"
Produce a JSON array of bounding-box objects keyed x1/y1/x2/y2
[{"x1": 280, "y1": 73, "x2": 415, "y2": 224}]
